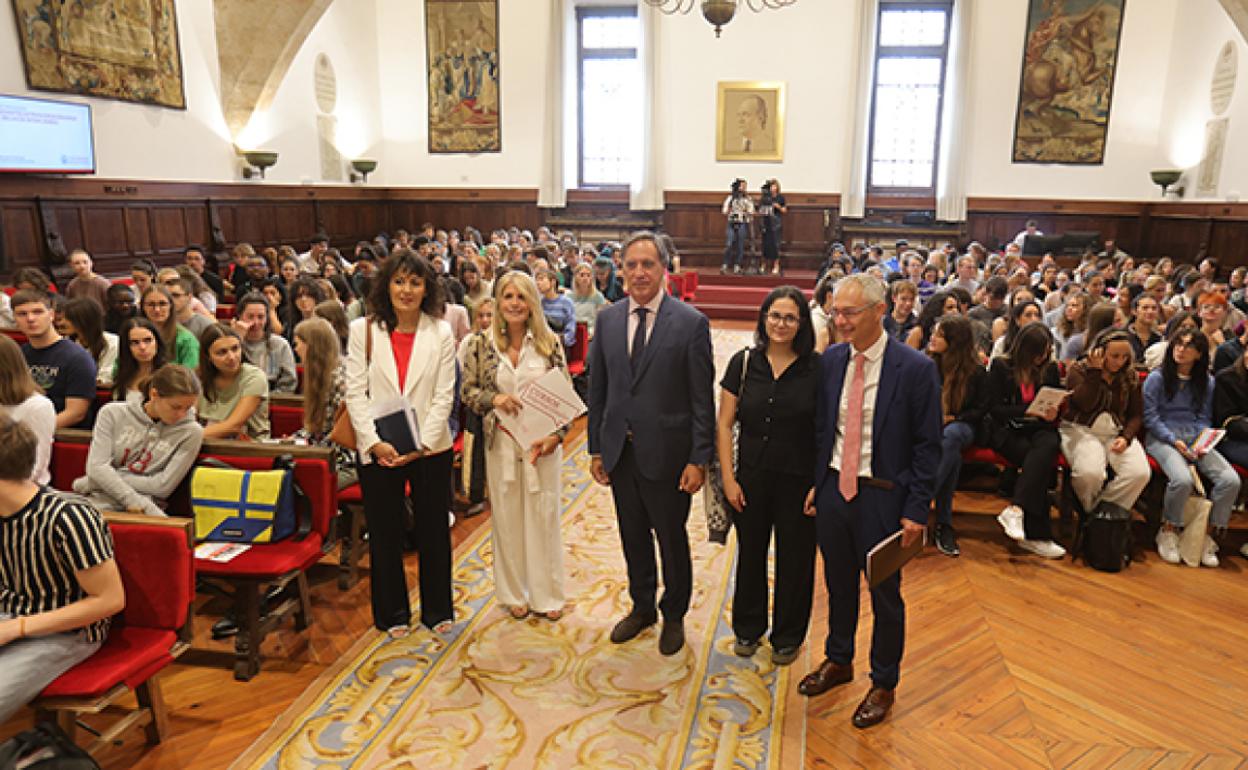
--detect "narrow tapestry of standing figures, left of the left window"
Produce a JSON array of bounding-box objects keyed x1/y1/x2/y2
[{"x1": 424, "y1": 0, "x2": 503, "y2": 152}]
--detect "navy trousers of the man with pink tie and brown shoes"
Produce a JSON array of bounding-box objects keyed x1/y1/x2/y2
[{"x1": 815, "y1": 472, "x2": 906, "y2": 690}]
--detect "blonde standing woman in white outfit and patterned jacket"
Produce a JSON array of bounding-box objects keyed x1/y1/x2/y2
[{"x1": 463, "y1": 271, "x2": 568, "y2": 620}]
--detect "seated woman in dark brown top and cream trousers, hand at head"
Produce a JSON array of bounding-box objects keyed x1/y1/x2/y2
[{"x1": 1061, "y1": 329, "x2": 1152, "y2": 512}]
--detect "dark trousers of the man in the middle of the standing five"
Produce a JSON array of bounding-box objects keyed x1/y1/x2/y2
[{"x1": 610, "y1": 442, "x2": 694, "y2": 620}]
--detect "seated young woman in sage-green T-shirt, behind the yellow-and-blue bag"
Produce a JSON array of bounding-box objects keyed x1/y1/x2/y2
[{"x1": 196, "y1": 323, "x2": 268, "y2": 439}]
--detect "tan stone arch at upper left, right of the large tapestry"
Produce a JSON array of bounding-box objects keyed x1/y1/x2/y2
[{"x1": 212, "y1": 0, "x2": 333, "y2": 136}]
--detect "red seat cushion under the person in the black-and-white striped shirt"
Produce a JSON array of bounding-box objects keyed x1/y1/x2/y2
[{"x1": 42, "y1": 625, "x2": 177, "y2": 698}]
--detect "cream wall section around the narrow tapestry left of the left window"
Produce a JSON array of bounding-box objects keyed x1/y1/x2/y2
[{"x1": 371, "y1": 0, "x2": 550, "y2": 188}]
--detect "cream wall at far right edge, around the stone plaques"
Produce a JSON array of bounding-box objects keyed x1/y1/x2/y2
[{"x1": 1158, "y1": 0, "x2": 1248, "y2": 200}]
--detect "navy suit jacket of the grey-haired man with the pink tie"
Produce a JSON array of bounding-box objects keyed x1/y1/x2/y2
[{"x1": 815, "y1": 338, "x2": 942, "y2": 524}]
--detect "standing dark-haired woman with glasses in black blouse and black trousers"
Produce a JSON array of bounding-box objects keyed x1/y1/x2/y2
[{"x1": 716, "y1": 286, "x2": 819, "y2": 665}]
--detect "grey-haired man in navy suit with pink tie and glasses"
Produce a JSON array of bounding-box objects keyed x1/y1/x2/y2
[{"x1": 797, "y1": 273, "x2": 941, "y2": 728}]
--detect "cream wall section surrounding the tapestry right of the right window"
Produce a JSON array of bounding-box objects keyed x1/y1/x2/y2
[{"x1": 967, "y1": 0, "x2": 1178, "y2": 200}]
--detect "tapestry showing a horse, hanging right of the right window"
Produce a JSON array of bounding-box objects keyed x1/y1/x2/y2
[{"x1": 1013, "y1": 0, "x2": 1126, "y2": 163}]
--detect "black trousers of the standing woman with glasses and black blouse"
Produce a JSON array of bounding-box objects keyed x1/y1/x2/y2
[{"x1": 733, "y1": 473, "x2": 815, "y2": 649}]
